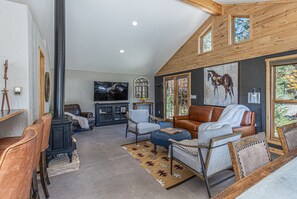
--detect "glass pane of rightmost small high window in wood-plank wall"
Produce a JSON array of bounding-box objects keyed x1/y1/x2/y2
[{"x1": 232, "y1": 17, "x2": 251, "y2": 44}]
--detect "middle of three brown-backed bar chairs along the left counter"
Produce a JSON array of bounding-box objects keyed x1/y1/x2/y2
[{"x1": 27, "y1": 119, "x2": 44, "y2": 198}]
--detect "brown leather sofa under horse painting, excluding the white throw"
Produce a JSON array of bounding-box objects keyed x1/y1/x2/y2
[{"x1": 173, "y1": 106, "x2": 256, "y2": 138}]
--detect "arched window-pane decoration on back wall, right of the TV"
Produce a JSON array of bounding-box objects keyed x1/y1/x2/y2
[{"x1": 134, "y1": 77, "x2": 149, "y2": 99}]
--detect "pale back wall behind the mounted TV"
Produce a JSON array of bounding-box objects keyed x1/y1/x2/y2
[{"x1": 65, "y1": 70, "x2": 155, "y2": 113}]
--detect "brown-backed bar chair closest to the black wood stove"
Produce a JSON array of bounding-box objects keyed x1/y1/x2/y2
[{"x1": 39, "y1": 113, "x2": 52, "y2": 198}]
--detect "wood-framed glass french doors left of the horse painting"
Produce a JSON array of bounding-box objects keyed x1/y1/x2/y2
[{"x1": 163, "y1": 73, "x2": 191, "y2": 120}]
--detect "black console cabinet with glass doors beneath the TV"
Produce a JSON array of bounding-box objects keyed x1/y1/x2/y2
[{"x1": 95, "y1": 103, "x2": 129, "y2": 126}]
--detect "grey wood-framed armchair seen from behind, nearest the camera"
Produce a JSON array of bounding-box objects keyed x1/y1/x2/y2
[{"x1": 169, "y1": 125, "x2": 241, "y2": 198}]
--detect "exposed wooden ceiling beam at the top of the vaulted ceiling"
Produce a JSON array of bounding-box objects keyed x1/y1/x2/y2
[{"x1": 182, "y1": 0, "x2": 223, "y2": 15}]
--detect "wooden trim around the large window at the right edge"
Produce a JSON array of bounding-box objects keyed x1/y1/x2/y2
[{"x1": 265, "y1": 54, "x2": 297, "y2": 146}]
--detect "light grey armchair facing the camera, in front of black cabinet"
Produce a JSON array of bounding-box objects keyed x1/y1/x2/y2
[{"x1": 126, "y1": 110, "x2": 160, "y2": 145}]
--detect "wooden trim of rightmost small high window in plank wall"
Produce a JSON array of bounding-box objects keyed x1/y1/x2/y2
[{"x1": 229, "y1": 15, "x2": 253, "y2": 45}]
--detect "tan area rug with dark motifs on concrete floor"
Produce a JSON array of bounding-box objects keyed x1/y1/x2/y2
[{"x1": 122, "y1": 141, "x2": 194, "y2": 189}]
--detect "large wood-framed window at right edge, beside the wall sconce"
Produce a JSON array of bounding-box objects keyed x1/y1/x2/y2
[{"x1": 266, "y1": 56, "x2": 297, "y2": 144}]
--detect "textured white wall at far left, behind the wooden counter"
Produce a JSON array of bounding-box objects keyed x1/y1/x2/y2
[{"x1": 0, "y1": 1, "x2": 50, "y2": 137}]
